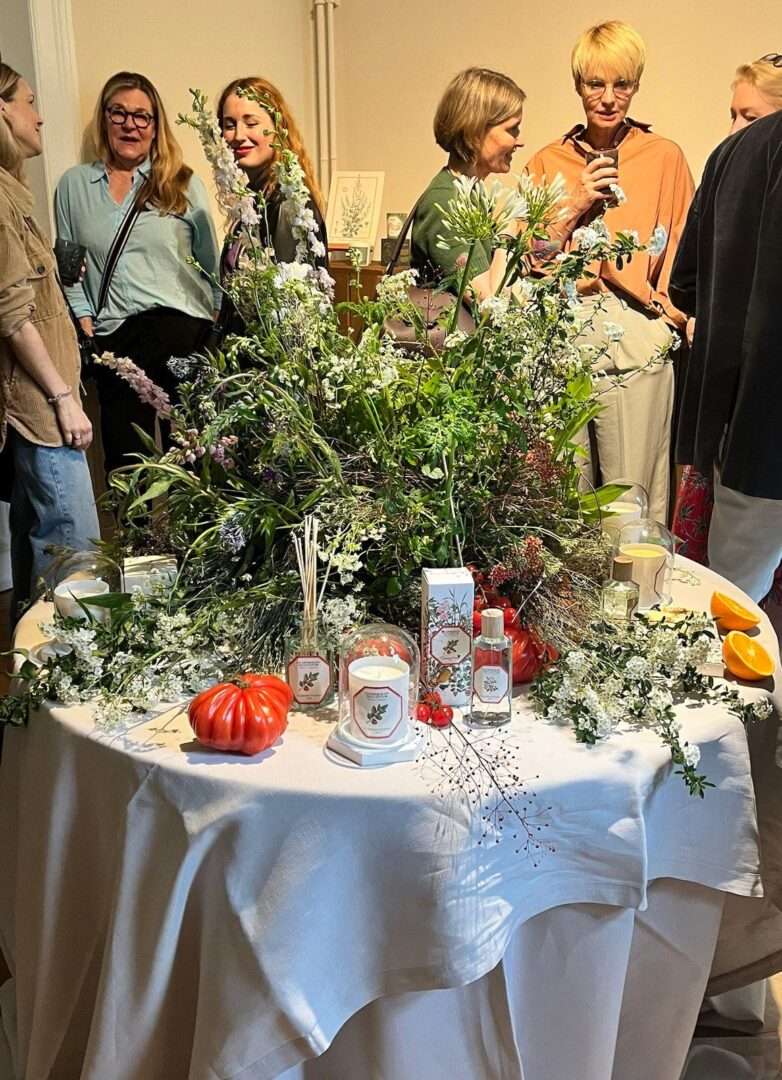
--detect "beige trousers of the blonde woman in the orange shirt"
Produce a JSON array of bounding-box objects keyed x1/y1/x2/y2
[{"x1": 579, "y1": 293, "x2": 673, "y2": 524}]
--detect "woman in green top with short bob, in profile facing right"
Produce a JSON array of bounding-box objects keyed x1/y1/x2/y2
[{"x1": 410, "y1": 68, "x2": 526, "y2": 300}]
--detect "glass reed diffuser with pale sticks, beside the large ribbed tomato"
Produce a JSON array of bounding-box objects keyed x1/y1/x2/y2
[{"x1": 285, "y1": 514, "x2": 334, "y2": 713}]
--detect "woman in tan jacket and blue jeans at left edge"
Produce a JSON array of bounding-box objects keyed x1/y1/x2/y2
[{"x1": 0, "y1": 60, "x2": 99, "y2": 604}]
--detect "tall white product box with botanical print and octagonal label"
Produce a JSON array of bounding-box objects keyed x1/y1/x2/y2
[{"x1": 421, "y1": 567, "x2": 475, "y2": 708}]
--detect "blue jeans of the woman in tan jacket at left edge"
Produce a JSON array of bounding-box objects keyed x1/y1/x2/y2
[{"x1": 8, "y1": 427, "x2": 100, "y2": 605}]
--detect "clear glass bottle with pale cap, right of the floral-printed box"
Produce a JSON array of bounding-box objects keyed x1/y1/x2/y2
[{"x1": 470, "y1": 608, "x2": 513, "y2": 728}]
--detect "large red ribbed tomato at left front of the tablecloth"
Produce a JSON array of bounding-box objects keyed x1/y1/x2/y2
[{"x1": 188, "y1": 674, "x2": 293, "y2": 754}]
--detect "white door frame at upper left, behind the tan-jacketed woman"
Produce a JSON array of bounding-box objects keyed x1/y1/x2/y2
[{"x1": 27, "y1": 0, "x2": 81, "y2": 235}]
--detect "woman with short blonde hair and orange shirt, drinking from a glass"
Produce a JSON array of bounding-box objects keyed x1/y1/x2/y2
[{"x1": 527, "y1": 22, "x2": 693, "y2": 522}]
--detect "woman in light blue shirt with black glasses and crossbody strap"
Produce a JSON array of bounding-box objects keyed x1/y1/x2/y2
[{"x1": 55, "y1": 71, "x2": 220, "y2": 474}]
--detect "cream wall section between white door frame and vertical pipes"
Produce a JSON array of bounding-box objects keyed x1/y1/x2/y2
[{"x1": 68, "y1": 0, "x2": 315, "y2": 221}]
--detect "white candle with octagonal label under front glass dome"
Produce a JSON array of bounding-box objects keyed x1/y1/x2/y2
[{"x1": 348, "y1": 657, "x2": 410, "y2": 745}]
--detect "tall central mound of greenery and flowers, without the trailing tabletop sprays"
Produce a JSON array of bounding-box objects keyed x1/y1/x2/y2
[{"x1": 102, "y1": 93, "x2": 678, "y2": 660}]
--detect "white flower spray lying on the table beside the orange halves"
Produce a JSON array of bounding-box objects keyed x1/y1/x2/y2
[{"x1": 530, "y1": 612, "x2": 771, "y2": 798}]
